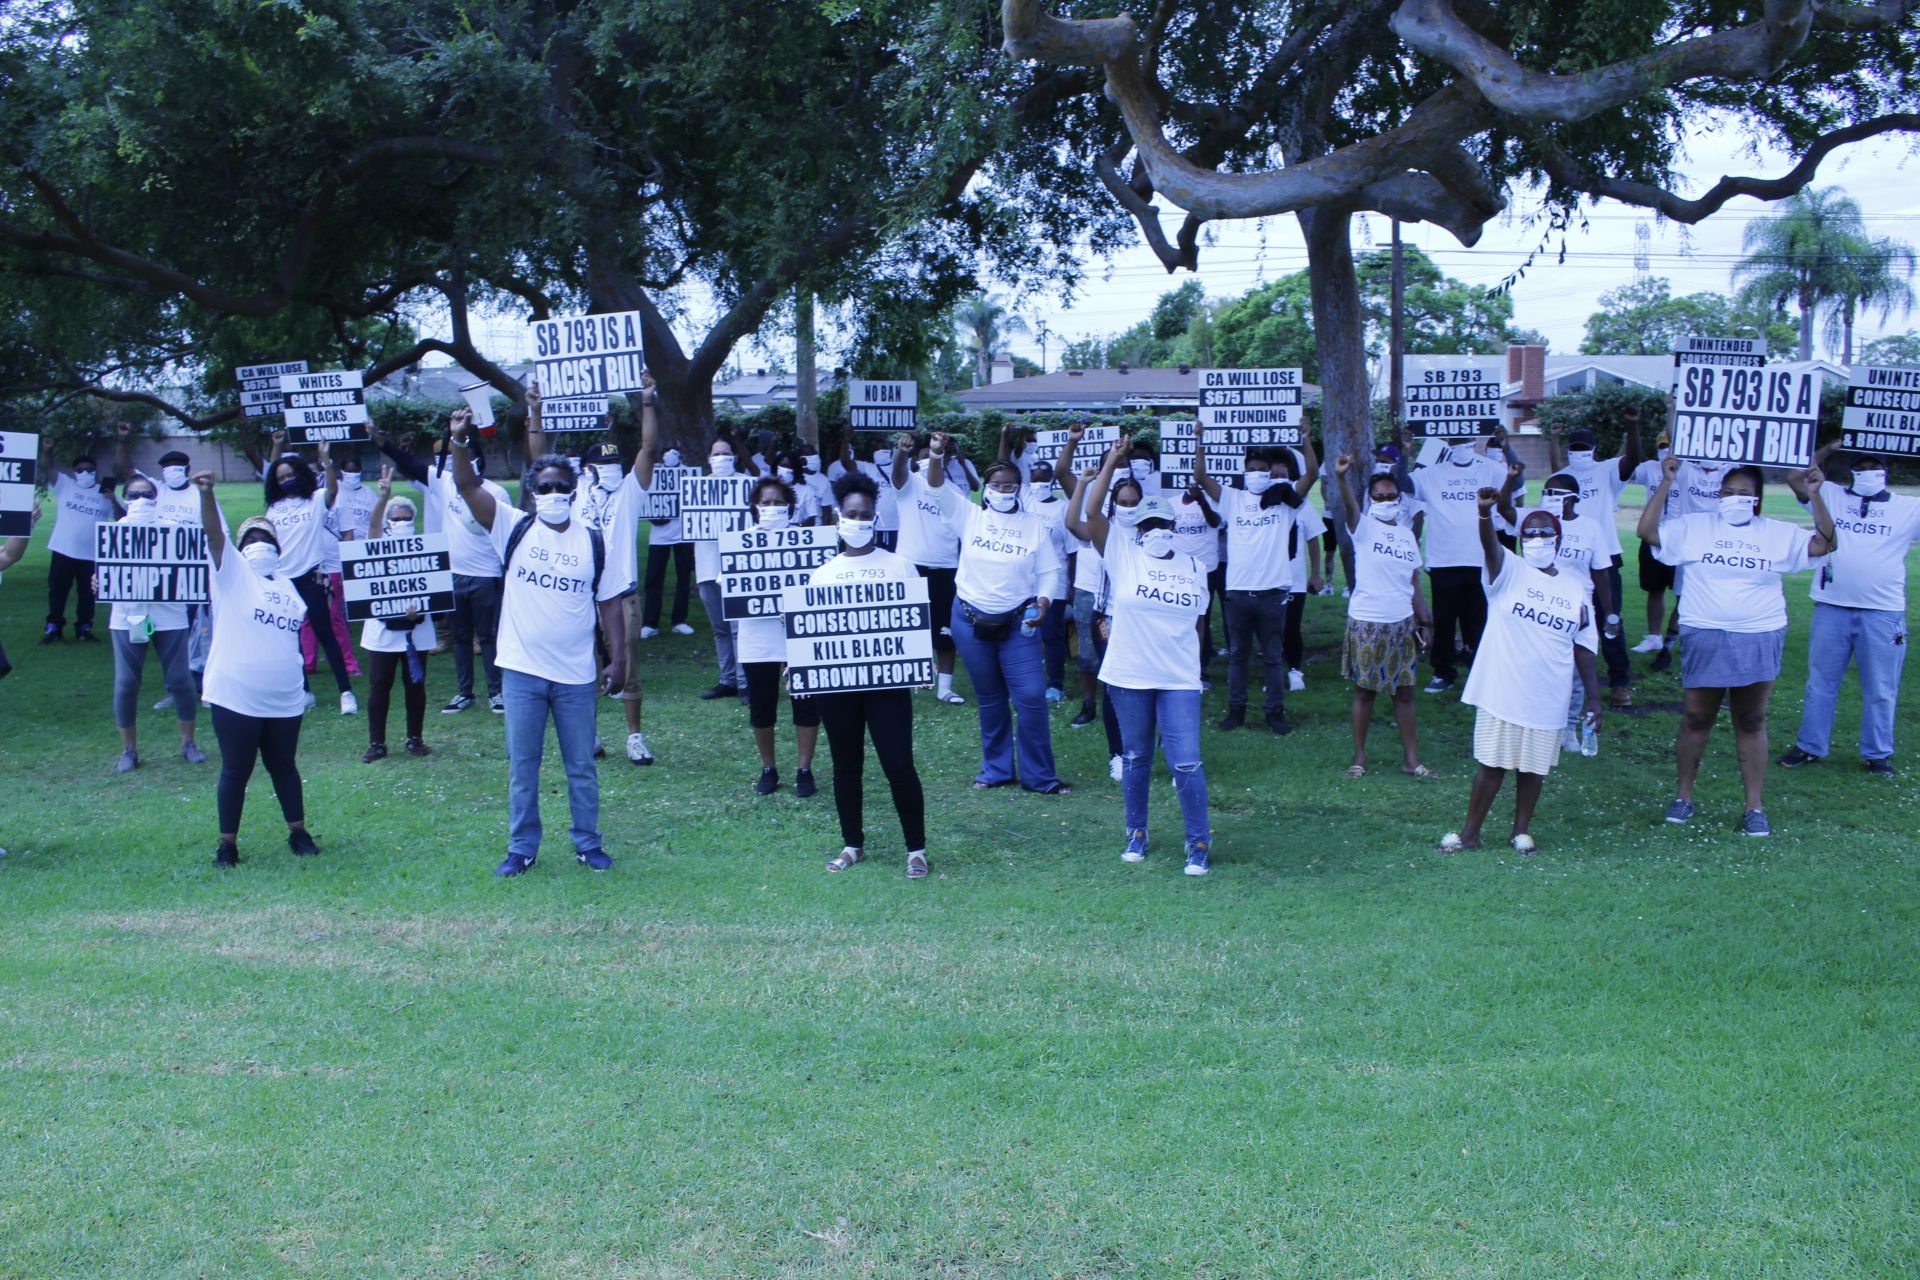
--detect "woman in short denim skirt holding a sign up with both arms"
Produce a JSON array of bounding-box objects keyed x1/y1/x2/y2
[{"x1": 1640, "y1": 457, "x2": 1839, "y2": 837}]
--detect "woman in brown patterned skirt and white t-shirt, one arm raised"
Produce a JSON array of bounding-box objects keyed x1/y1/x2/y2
[{"x1": 1334, "y1": 455, "x2": 1434, "y2": 777}]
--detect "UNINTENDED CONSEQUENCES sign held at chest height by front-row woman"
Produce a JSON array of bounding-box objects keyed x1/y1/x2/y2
[{"x1": 780, "y1": 578, "x2": 933, "y2": 695}]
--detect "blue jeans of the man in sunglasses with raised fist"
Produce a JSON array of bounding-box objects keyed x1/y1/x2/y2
[{"x1": 499, "y1": 668, "x2": 601, "y2": 858}]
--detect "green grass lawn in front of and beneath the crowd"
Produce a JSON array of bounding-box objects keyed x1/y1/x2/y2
[{"x1": 0, "y1": 486, "x2": 1920, "y2": 1278}]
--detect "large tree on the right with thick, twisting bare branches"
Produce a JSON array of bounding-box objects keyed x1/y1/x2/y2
[{"x1": 1000, "y1": 0, "x2": 1920, "y2": 460}]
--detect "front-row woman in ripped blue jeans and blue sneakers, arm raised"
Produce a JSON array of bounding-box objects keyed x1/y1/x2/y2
[{"x1": 1069, "y1": 438, "x2": 1212, "y2": 875}]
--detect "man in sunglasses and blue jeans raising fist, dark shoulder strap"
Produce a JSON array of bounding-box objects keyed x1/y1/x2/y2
[{"x1": 449, "y1": 409, "x2": 632, "y2": 875}]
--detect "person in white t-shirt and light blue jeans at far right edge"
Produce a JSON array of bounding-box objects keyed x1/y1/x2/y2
[{"x1": 1780, "y1": 449, "x2": 1920, "y2": 777}]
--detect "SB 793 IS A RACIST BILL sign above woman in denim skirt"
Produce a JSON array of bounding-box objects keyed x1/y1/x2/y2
[{"x1": 1670, "y1": 365, "x2": 1820, "y2": 468}]
